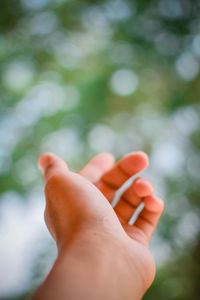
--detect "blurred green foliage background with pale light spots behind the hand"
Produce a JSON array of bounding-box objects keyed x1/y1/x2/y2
[{"x1": 0, "y1": 0, "x2": 200, "y2": 300}]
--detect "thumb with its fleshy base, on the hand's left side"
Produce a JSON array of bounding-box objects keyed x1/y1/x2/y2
[{"x1": 38, "y1": 153, "x2": 124, "y2": 236}]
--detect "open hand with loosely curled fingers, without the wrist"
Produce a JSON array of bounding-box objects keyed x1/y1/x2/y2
[{"x1": 36, "y1": 152, "x2": 163, "y2": 299}]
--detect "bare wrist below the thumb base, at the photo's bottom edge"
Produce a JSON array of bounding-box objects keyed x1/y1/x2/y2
[{"x1": 33, "y1": 231, "x2": 145, "y2": 300}]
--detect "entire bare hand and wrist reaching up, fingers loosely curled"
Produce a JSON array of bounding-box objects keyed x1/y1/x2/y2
[{"x1": 32, "y1": 152, "x2": 164, "y2": 300}]
